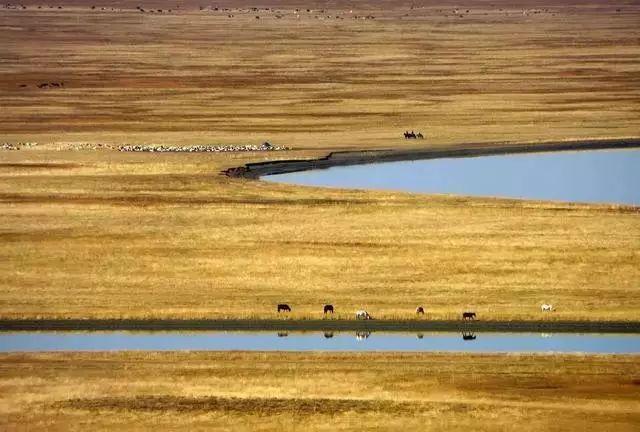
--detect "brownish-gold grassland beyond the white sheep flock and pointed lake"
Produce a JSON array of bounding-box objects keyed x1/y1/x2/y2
[{"x1": 0, "y1": 0, "x2": 640, "y2": 148}]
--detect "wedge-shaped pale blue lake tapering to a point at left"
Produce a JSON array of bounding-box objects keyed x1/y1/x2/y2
[{"x1": 264, "y1": 149, "x2": 640, "y2": 205}]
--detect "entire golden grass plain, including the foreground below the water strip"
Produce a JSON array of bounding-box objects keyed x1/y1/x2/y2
[{"x1": 0, "y1": 0, "x2": 640, "y2": 431}]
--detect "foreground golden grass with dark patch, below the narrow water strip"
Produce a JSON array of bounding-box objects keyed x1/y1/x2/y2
[{"x1": 0, "y1": 352, "x2": 640, "y2": 431}]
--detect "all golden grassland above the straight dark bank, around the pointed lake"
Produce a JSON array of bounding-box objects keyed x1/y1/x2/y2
[{"x1": 0, "y1": 2, "x2": 640, "y2": 320}]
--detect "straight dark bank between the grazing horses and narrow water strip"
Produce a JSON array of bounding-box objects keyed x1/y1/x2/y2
[{"x1": 0, "y1": 319, "x2": 640, "y2": 333}]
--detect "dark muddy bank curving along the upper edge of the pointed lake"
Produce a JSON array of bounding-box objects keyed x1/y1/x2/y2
[{"x1": 221, "y1": 138, "x2": 640, "y2": 179}]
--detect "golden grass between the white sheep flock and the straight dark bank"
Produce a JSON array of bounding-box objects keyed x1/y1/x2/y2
[{"x1": 0, "y1": 151, "x2": 640, "y2": 320}]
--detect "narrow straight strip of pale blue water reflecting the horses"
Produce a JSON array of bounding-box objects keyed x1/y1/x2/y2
[{"x1": 0, "y1": 331, "x2": 640, "y2": 354}]
